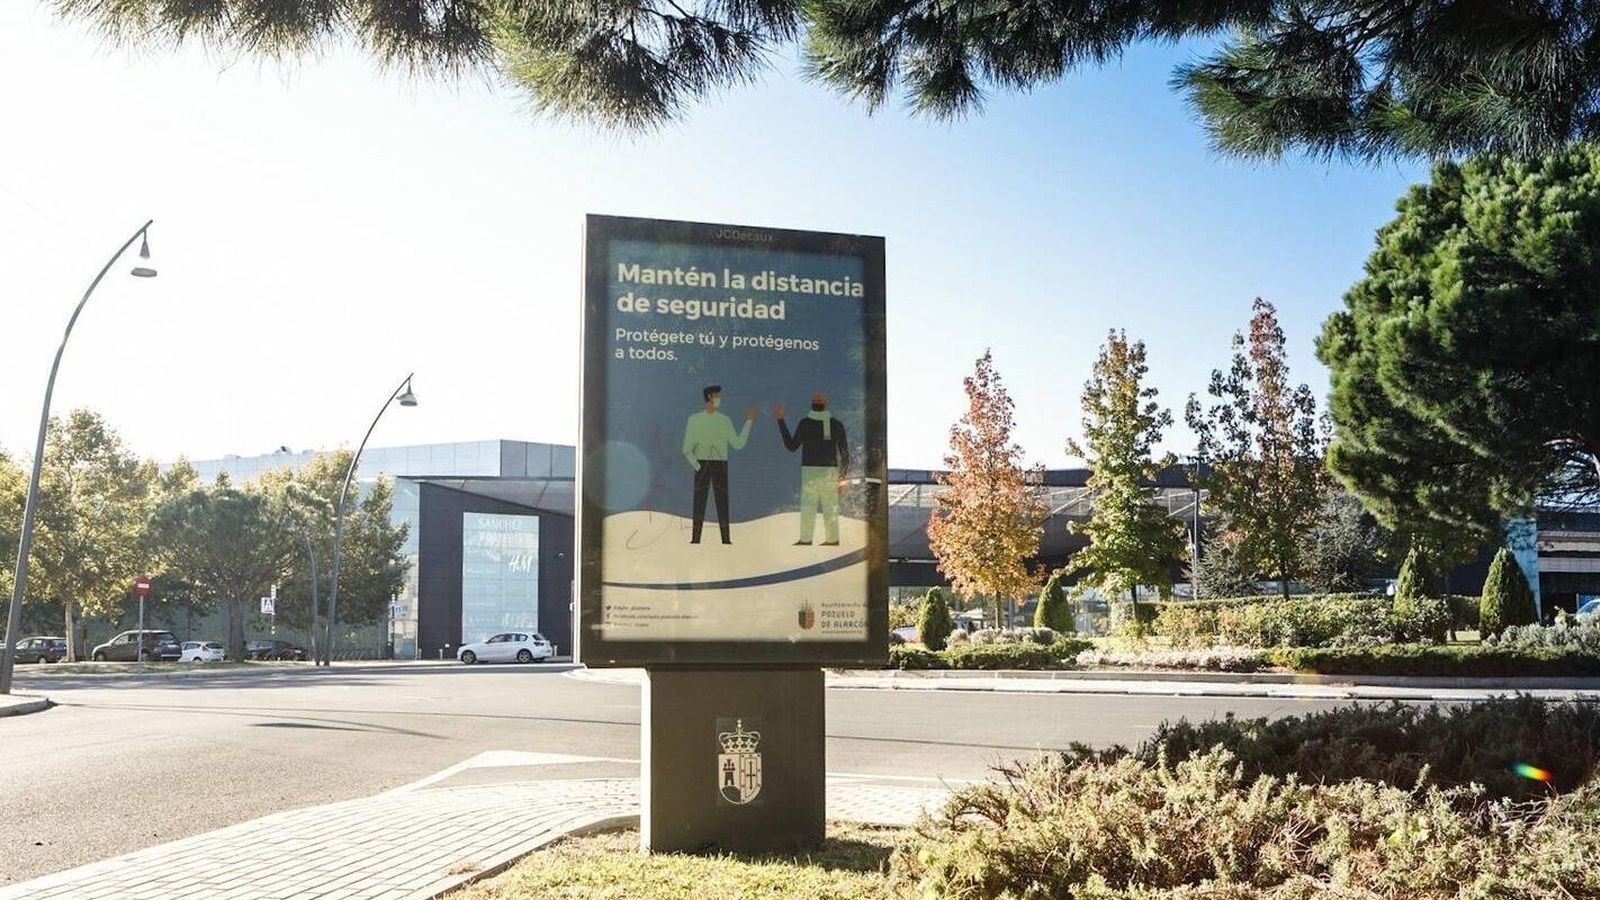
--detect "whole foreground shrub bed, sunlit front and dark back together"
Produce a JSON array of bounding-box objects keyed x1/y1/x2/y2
[{"x1": 890, "y1": 697, "x2": 1600, "y2": 900}]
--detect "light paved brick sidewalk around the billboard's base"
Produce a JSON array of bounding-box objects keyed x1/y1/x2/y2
[{"x1": 0, "y1": 751, "x2": 946, "y2": 900}]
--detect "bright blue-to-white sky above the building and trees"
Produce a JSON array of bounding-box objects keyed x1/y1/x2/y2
[{"x1": 0, "y1": 0, "x2": 1426, "y2": 468}]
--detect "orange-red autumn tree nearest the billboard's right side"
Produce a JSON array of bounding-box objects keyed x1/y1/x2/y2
[{"x1": 928, "y1": 351, "x2": 1046, "y2": 623}]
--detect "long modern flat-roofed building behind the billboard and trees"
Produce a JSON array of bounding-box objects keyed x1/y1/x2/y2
[{"x1": 192, "y1": 440, "x2": 1600, "y2": 658}]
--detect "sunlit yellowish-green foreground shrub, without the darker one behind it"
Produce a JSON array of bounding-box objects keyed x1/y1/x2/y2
[{"x1": 890, "y1": 749, "x2": 1600, "y2": 900}]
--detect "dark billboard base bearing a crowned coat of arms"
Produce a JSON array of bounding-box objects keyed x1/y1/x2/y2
[{"x1": 638, "y1": 668, "x2": 827, "y2": 852}]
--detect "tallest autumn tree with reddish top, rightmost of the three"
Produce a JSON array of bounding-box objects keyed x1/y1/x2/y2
[{"x1": 1186, "y1": 298, "x2": 1328, "y2": 597}]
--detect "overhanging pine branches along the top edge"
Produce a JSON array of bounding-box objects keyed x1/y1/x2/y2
[{"x1": 54, "y1": 0, "x2": 1600, "y2": 159}]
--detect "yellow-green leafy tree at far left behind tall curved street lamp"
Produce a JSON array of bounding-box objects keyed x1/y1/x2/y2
[{"x1": 24, "y1": 410, "x2": 162, "y2": 658}]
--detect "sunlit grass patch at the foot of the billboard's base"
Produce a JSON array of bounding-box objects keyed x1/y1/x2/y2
[{"x1": 448, "y1": 823, "x2": 906, "y2": 900}]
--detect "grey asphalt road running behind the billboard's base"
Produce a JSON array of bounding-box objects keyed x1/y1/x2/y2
[{"x1": 0, "y1": 666, "x2": 1388, "y2": 884}]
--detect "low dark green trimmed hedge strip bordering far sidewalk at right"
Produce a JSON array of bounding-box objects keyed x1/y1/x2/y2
[{"x1": 1266, "y1": 644, "x2": 1600, "y2": 677}]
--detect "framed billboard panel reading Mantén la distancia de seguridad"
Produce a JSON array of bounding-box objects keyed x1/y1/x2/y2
[{"x1": 578, "y1": 216, "x2": 888, "y2": 666}]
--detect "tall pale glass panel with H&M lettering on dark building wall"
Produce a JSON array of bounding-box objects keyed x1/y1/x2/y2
[{"x1": 461, "y1": 512, "x2": 539, "y2": 642}]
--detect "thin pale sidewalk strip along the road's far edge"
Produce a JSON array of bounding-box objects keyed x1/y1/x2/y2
[{"x1": 566, "y1": 668, "x2": 1600, "y2": 701}]
